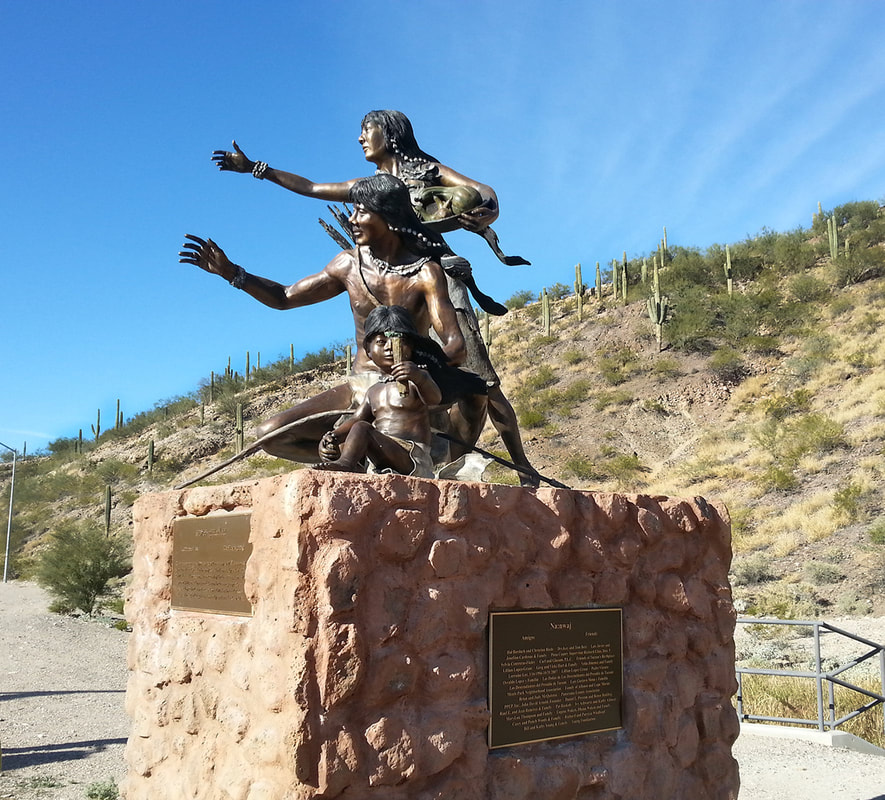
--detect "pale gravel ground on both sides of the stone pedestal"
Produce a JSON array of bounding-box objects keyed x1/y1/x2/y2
[{"x1": 0, "y1": 581, "x2": 885, "y2": 800}]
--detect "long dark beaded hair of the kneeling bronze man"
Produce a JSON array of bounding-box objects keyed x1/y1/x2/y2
[{"x1": 350, "y1": 172, "x2": 452, "y2": 258}]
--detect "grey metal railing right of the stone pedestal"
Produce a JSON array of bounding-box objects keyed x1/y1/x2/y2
[{"x1": 735, "y1": 617, "x2": 885, "y2": 732}]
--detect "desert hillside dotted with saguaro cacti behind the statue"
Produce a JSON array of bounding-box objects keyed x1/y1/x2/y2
[{"x1": 0, "y1": 198, "x2": 885, "y2": 617}]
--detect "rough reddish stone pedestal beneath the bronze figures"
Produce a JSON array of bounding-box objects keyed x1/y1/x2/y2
[{"x1": 123, "y1": 470, "x2": 738, "y2": 800}]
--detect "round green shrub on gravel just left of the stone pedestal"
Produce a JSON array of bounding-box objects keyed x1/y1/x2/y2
[{"x1": 37, "y1": 522, "x2": 129, "y2": 615}]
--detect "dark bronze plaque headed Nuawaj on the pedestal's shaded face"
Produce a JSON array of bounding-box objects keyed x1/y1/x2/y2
[{"x1": 489, "y1": 608, "x2": 624, "y2": 748}]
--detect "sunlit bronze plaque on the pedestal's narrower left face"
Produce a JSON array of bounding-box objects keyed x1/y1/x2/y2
[{"x1": 172, "y1": 514, "x2": 252, "y2": 617}]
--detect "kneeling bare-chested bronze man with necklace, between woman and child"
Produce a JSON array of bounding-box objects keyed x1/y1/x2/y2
[{"x1": 179, "y1": 174, "x2": 465, "y2": 463}]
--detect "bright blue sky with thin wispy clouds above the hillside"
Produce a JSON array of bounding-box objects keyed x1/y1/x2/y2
[{"x1": 0, "y1": 0, "x2": 885, "y2": 451}]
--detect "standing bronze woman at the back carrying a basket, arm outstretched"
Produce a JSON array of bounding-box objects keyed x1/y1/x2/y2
[{"x1": 212, "y1": 110, "x2": 537, "y2": 485}]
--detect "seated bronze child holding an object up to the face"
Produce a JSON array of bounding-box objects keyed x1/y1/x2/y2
[{"x1": 315, "y1": 306, "x2": 485, "y2": 478}]
